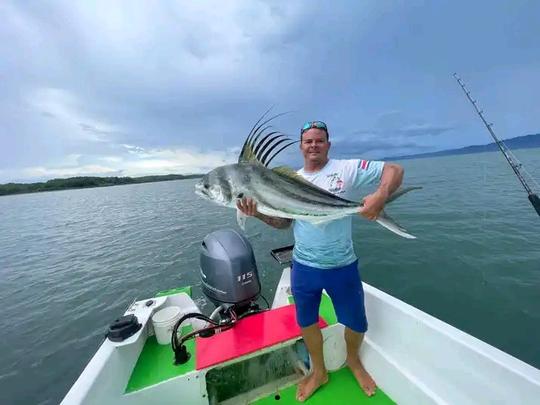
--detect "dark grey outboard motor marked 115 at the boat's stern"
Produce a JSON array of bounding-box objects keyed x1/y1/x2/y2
[{"x1": 200, "y1": 229, "x2": 261, "y2": 315}]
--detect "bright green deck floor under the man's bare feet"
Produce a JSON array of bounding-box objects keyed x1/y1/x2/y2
[{"x1": 251, "y1": 368, "x2": 395, "y2": 405}]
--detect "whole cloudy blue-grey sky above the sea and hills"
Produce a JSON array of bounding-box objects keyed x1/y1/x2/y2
[{"x1": 0, "y1": 0, "x2": 540, "y2": 183}]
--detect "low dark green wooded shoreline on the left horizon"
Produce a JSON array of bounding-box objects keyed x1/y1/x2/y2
[{"x1": 0, "y1": 174, "x2": 203, "y2": 196}]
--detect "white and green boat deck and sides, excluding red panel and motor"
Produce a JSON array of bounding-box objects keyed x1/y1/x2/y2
[{"x1": 62, "y1": 268, "x2": 540, "y2": 405}]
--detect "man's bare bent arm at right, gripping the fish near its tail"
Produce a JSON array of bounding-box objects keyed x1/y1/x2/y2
[{"x1": 360, "y1": 163, "x2": 405, "y2": 221}]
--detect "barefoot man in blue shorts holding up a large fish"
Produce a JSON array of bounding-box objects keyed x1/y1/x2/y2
[{"x1": 237, "y1": 121, "x2": 403, "y2": 402}]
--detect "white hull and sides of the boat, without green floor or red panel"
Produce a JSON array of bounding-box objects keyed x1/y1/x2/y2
[{"x1": 62, "y1": 268, "x2": 540, "y2": 405}]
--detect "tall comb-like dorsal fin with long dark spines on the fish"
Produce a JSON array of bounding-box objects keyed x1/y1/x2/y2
[{"x1": 238, "y1": 110, "x2": 298, "y2": 167}]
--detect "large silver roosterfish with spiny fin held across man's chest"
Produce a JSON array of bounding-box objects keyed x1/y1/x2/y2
[{"x1": 195, "y1": 113, "x2": 421, "y2": 239}]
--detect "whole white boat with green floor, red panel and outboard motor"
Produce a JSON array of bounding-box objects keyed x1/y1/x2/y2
[{"x1": 62, "y1": 230, "x2": 540, "y2": 405}]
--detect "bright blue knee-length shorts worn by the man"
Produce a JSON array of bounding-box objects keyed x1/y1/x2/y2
[{"x1": 291, "y1": 260, "x2": 367, "y2": 333}]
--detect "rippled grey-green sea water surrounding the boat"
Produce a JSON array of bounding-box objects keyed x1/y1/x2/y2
[{"x1": 0, "y1": 149, "x2": 540, "y2": 404}]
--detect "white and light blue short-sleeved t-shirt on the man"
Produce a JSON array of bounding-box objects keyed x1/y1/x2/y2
[{"x1": 293, "y1": 159, "x2": 384, "y2": 269}]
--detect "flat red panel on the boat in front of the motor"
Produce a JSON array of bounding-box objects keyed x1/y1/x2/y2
[{"x1": 195, "y1": 305, "x2": 327, "y2": 370}]
